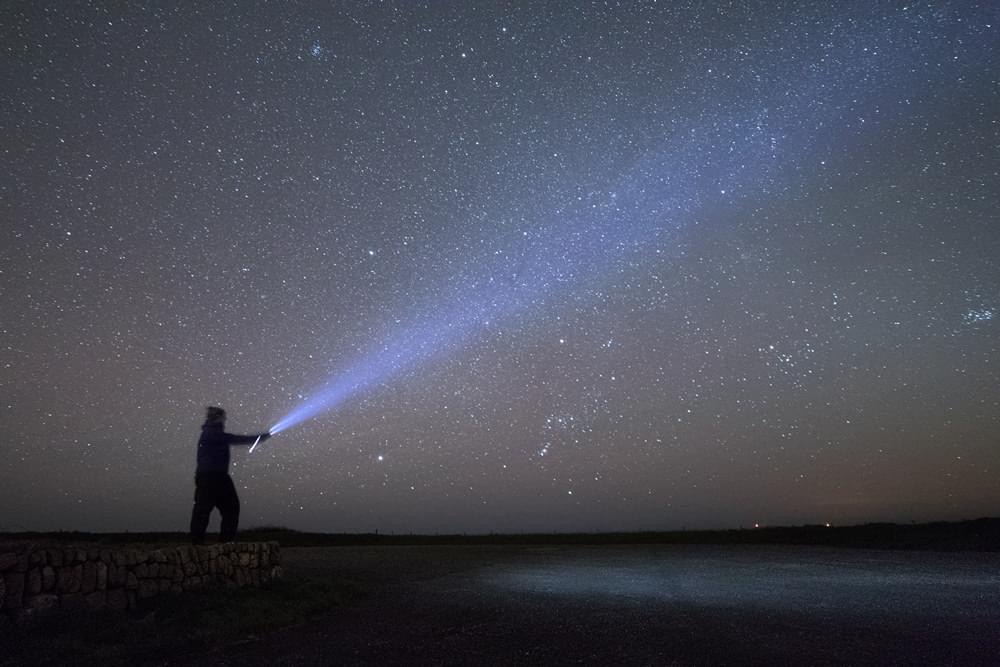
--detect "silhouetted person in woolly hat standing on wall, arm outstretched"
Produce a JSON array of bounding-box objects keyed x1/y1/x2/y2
[{"x1": 191, "y1": 407, "x2": 271, "y2": 544}]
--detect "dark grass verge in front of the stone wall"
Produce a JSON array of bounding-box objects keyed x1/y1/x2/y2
[{"x1": 0, "y1": 572, "x2": 361, "y2": 667}]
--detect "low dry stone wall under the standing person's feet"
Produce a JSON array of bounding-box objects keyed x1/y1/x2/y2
[{"x1": 0, "y1": 542, "x2": 281, "y2": 621}]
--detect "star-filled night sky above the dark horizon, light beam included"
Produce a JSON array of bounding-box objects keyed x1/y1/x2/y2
[{"x1": 0, "y1": 0, "x2": 1000, "y2": 533}]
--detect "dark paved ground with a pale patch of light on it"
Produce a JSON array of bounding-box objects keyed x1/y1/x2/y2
[{"x1": 184, "y1": 546, "x2": 1000, "y2": 666}]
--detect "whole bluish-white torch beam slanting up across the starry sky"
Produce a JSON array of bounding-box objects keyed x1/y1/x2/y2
[{"x1": 270, "y1": 16, "x2": 984, "y2": 434}]
